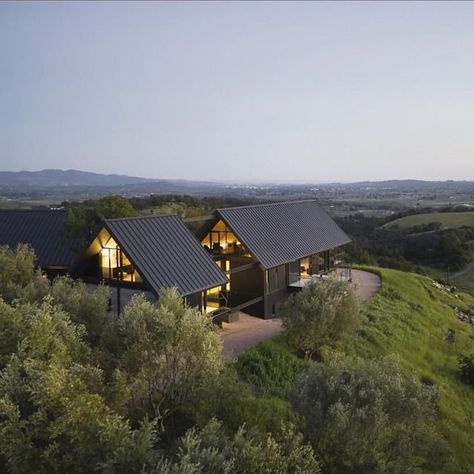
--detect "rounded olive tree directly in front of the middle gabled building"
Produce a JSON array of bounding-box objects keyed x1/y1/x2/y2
[{"x1": 112, "y1": 289, "x2": 223, "y2": 428}]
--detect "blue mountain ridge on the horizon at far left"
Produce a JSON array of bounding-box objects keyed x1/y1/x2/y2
[{"x1": 0, "y1": 169, "x2": 158, "y2": 187}]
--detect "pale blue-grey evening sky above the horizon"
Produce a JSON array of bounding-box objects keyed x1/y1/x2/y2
[{"x1": 0, "y1": 2, "x2": 474, "y2": 182}]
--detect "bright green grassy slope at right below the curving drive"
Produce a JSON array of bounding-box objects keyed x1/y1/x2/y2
[{"x1": 346, "y1": 269, "x2": 474, "y2": 472}]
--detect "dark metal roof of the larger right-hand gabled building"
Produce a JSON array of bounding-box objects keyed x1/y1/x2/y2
[{"x1": 216, "y1": 201, "x2": 351, "y2": 268}]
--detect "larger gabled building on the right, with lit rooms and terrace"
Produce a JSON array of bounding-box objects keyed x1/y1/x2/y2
[{"x1": 200, "y1": 201, "x2": 350, "y2": 318}]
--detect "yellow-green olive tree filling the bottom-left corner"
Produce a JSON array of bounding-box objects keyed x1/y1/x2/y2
[{"x1": 0, "y1": 298, "x2": 155, "y2": 473}]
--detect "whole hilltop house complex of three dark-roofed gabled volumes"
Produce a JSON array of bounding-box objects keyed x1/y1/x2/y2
[{"x1": 0, "y1": 201, "x2": 350, "y2": 318}]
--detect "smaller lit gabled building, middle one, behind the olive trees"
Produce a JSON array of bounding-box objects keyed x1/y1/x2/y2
[{"x1": 86, "y1": 215, "x2": 228, "y2": 306}]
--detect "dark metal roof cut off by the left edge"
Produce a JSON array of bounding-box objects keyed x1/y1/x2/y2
[{"x1": 0, "y1": 210, "x2": 78, "y2": 267}]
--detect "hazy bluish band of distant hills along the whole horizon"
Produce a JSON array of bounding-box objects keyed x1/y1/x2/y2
[{"x1": 0, "y1": 169, "x2": 474, "y2": 199}]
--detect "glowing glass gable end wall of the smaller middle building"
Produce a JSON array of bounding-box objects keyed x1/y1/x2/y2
[{"x1": 99, "y1": 237, "x2": 143, "y2": 283}]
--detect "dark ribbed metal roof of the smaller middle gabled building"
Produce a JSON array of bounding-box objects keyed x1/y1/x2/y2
[{"x1": 105, "y1": 215, "x2": 227, "y2": 296}]
